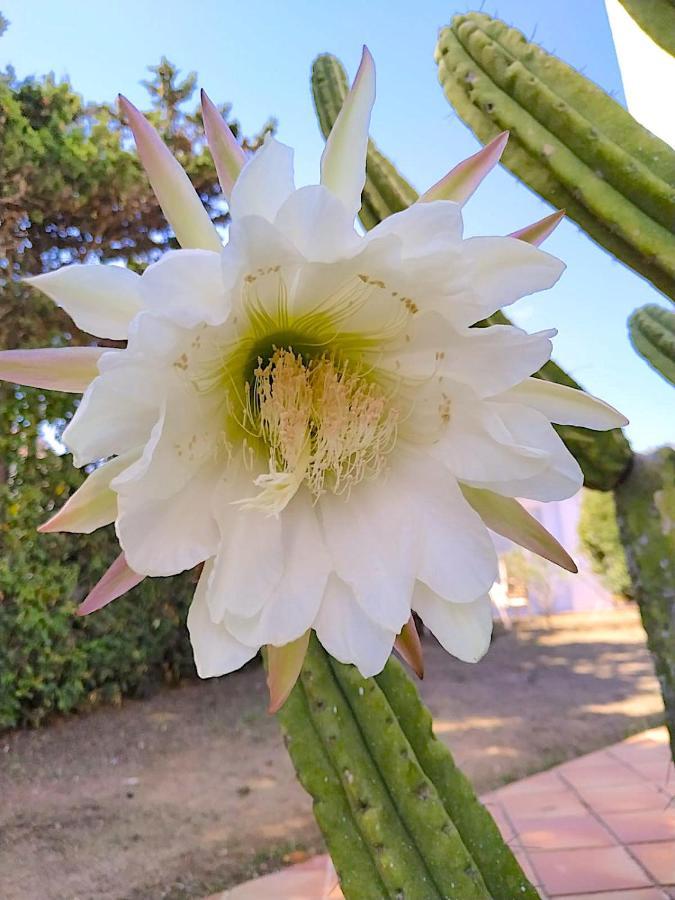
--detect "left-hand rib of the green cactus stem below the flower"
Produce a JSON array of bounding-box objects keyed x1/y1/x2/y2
[{"x1": 277, "y1": 672, "x2": 386, "y2": 900}]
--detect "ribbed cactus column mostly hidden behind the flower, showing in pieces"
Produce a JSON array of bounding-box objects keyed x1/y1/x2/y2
[{"x1": 312, "y1": 54, "x2": 632, "y2": 491}]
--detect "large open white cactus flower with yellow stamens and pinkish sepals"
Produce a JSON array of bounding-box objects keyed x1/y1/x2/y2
[{"x1": 0, "y1": 51, "x2": 626, "y2": 706}]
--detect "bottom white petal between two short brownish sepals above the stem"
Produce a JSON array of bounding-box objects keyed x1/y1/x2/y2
[{"x1": 314, "y1": 575, "x2": 396, "y2": 678}]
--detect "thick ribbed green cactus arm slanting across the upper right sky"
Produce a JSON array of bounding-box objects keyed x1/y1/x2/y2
[{"x1": 435, "y1": 13, "x2": 675, "y2": 299}]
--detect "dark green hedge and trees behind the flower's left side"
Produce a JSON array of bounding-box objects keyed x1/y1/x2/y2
[{"x1": 0, "y1": 44, "x2": 272, "y2": 728}]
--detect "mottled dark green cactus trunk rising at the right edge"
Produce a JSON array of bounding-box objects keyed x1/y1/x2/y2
[{"x1": 614, "y1": 447, "x2": 675, "y2": 761}]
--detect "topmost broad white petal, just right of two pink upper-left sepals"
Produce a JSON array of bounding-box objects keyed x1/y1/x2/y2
[{"x1": 230, "y1": 137, "x2": 295, "y2": 222}]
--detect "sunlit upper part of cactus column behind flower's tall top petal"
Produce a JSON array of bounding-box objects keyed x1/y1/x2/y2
[{"x1": 312, "y1": 53, "x2": 417, "y2": 229}]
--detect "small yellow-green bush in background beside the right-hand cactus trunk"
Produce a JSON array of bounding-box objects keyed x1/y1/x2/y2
[{"x1": 579, "y1": 491, "x2": 633, "y2": 597}]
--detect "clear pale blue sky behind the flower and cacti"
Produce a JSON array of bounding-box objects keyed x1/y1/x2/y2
[{"x1": 0, "y1": 0, "x2": 675, "y2": 450}]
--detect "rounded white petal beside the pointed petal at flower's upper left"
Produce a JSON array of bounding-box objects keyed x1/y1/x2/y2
[{"x1": 141, "y1": 250, "x2": 230, "y2": 328}]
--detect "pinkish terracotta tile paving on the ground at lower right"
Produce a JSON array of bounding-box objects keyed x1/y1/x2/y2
[{"x1": 219, "y1": 728, "x2": 675, "y2": 900}]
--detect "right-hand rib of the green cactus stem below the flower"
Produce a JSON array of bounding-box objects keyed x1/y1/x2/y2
[{"x1": 375, "y1": 659, "x2": 538, "y2": 900}]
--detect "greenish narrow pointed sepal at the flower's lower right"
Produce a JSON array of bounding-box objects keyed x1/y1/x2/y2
[{"x1": 460, "y1": 483, "x2": 578, "y2": 573}]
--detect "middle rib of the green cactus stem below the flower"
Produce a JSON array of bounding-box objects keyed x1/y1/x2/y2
[{"x1": 329, "y1": 659, "x2": 489, "y2": 900}]
